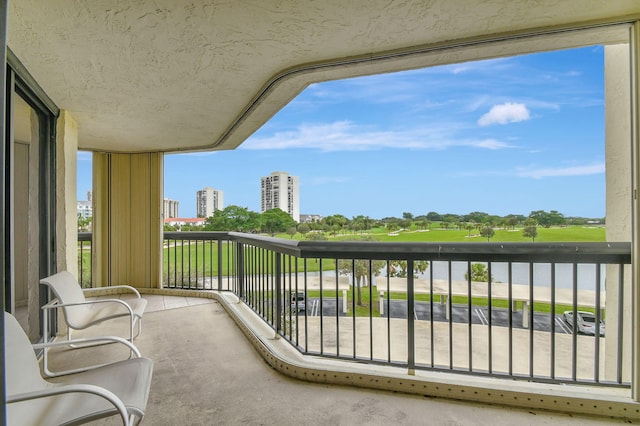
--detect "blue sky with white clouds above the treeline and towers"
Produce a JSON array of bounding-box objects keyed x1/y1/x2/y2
[{"x1": 78, "y1": 46, "x2": 605, "y2": 219}]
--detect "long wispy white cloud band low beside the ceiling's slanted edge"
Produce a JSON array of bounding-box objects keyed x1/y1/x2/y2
[{"x1": 240, "y1": 121, "x2": 513, "y2": 151}]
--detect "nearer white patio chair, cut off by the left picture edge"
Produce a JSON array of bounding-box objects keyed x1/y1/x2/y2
[{"x1": 4, "y1": 312, "x2": 153, "y2": 426}]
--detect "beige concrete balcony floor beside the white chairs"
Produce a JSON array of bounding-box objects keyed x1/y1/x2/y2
[{"x1": 42, "y1": 294, "x2": 630, "y2": 425}]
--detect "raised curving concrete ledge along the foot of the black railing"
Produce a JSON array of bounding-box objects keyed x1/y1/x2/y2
[{"x1": 127, "y1": 289, "x2": 640, "y2": 421}]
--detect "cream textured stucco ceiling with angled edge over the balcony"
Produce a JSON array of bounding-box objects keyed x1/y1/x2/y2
[{"x1": 8, "y1": 0, "x2": 640, "y2": 152}]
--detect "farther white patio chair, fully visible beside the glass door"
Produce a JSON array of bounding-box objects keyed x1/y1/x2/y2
[{"x1": 40, "y1": 271, "x2": 147, "y2": 342}]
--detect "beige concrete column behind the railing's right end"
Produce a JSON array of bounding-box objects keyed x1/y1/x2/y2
[{"x1": 604, "y1": 43, "x2": 637, "y2": 380}]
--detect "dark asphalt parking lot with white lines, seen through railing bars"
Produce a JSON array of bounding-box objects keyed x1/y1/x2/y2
[{"x1": 307, "y1": 298, "x2": 571, "y2": 334}]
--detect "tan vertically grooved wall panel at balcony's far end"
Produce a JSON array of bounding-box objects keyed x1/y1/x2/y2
[{"x1": 93, "y1": 153, "x2": 163, "y2": 288}]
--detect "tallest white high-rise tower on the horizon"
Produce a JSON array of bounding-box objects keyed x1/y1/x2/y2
[{"x1": 260, "y1": 172, "x2": 300, "y2": 222}]
